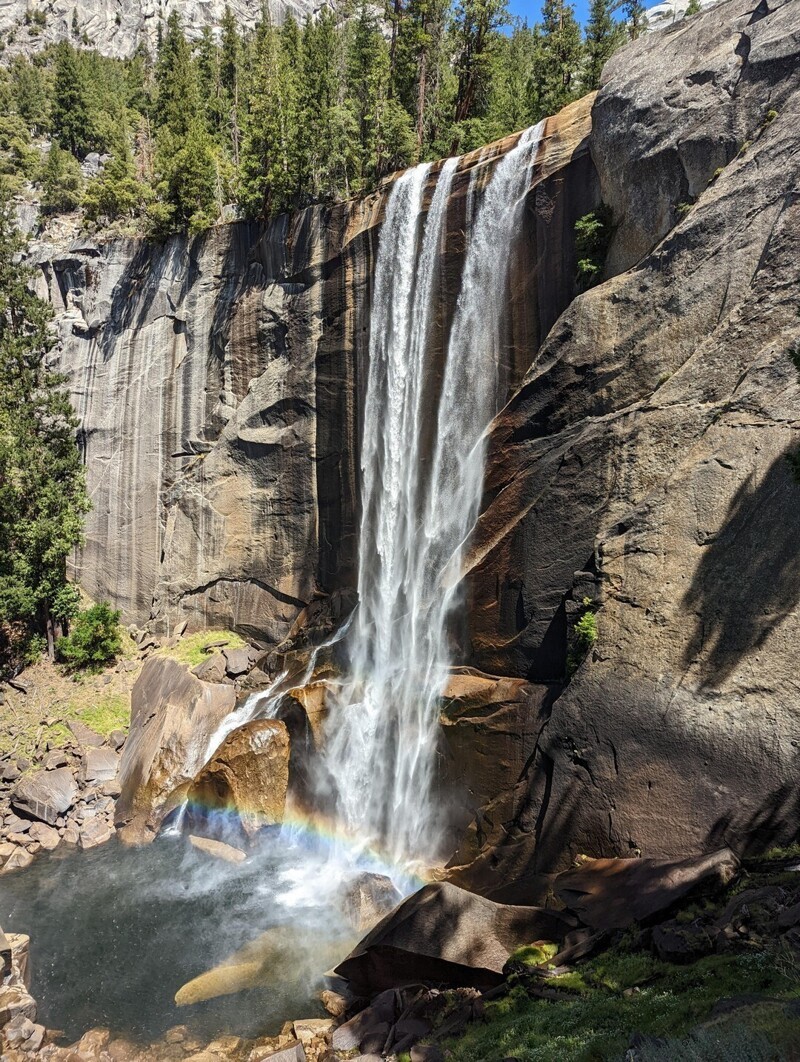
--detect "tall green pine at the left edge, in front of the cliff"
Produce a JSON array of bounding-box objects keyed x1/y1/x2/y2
[{"x1": 0, "y1": 191, "x2": 89, "y2": 669}]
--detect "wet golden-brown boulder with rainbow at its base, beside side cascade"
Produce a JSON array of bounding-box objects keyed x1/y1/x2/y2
[{"x1": 187, "y1": 719, "x2": 289, "y2": 837}]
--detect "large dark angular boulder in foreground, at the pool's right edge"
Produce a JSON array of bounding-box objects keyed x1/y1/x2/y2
[{"x1": 336, "y1": 883, "x2": 577, "y2": 995}]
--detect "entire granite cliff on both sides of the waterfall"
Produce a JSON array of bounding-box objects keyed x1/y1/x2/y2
[{"x1": 36, "y1": 0, "x2": 800, "y2": 887}]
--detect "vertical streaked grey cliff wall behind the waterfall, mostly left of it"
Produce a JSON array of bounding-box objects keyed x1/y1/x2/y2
[{"x1": 42, "y1": 99, "x2": 597, "y2": 645}]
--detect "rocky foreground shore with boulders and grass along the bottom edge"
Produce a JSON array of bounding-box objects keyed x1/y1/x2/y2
[{"x1": 0, "y1": 850, "x2": 800, "y2": 1062}]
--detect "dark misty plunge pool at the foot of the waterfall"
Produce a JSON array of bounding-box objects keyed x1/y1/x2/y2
[{"x1": 0, "y1": 838, "x2": 358, "y2": 1041}]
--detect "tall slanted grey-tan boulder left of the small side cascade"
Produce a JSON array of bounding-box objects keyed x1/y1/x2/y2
[{"x1": 116, "y1": 656, "x2": 236, "y2": 844}]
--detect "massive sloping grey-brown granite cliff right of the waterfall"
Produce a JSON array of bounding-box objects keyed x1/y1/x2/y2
[{"x1": 458, "y1": 0, "x2": 800, "y2": 896}]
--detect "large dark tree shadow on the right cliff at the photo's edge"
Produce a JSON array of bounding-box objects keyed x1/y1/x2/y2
[{"x1": 683, "y1": 453, "x2": 800, "y2": 688}]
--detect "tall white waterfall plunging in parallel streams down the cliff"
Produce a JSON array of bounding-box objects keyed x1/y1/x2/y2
[{"x1": 323, "y1": 123, "x2": 543, "y2": 861}]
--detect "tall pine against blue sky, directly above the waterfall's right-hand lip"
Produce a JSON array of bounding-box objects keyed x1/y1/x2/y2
[{"x1": 532, "y1": 0, "x2": 583, "y2": 119}]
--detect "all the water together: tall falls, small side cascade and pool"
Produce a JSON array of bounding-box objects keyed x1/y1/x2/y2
[{"x1": 0, "y1": 124, "x2": 542, "y2": 1040}]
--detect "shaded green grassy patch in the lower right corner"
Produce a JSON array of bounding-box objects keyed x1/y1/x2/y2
[{"x1": 446, "y1": 948, "x2": 800, "y2": 1062}]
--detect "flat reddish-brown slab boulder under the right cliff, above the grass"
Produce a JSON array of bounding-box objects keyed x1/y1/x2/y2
[{"x1": 555, "y1": 849, "x2": 739, "y2": 929}]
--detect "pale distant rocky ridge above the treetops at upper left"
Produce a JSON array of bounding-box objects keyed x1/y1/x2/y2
[{"x1": 0, "y1": 0, "x2": 325, "y2": 58}]
